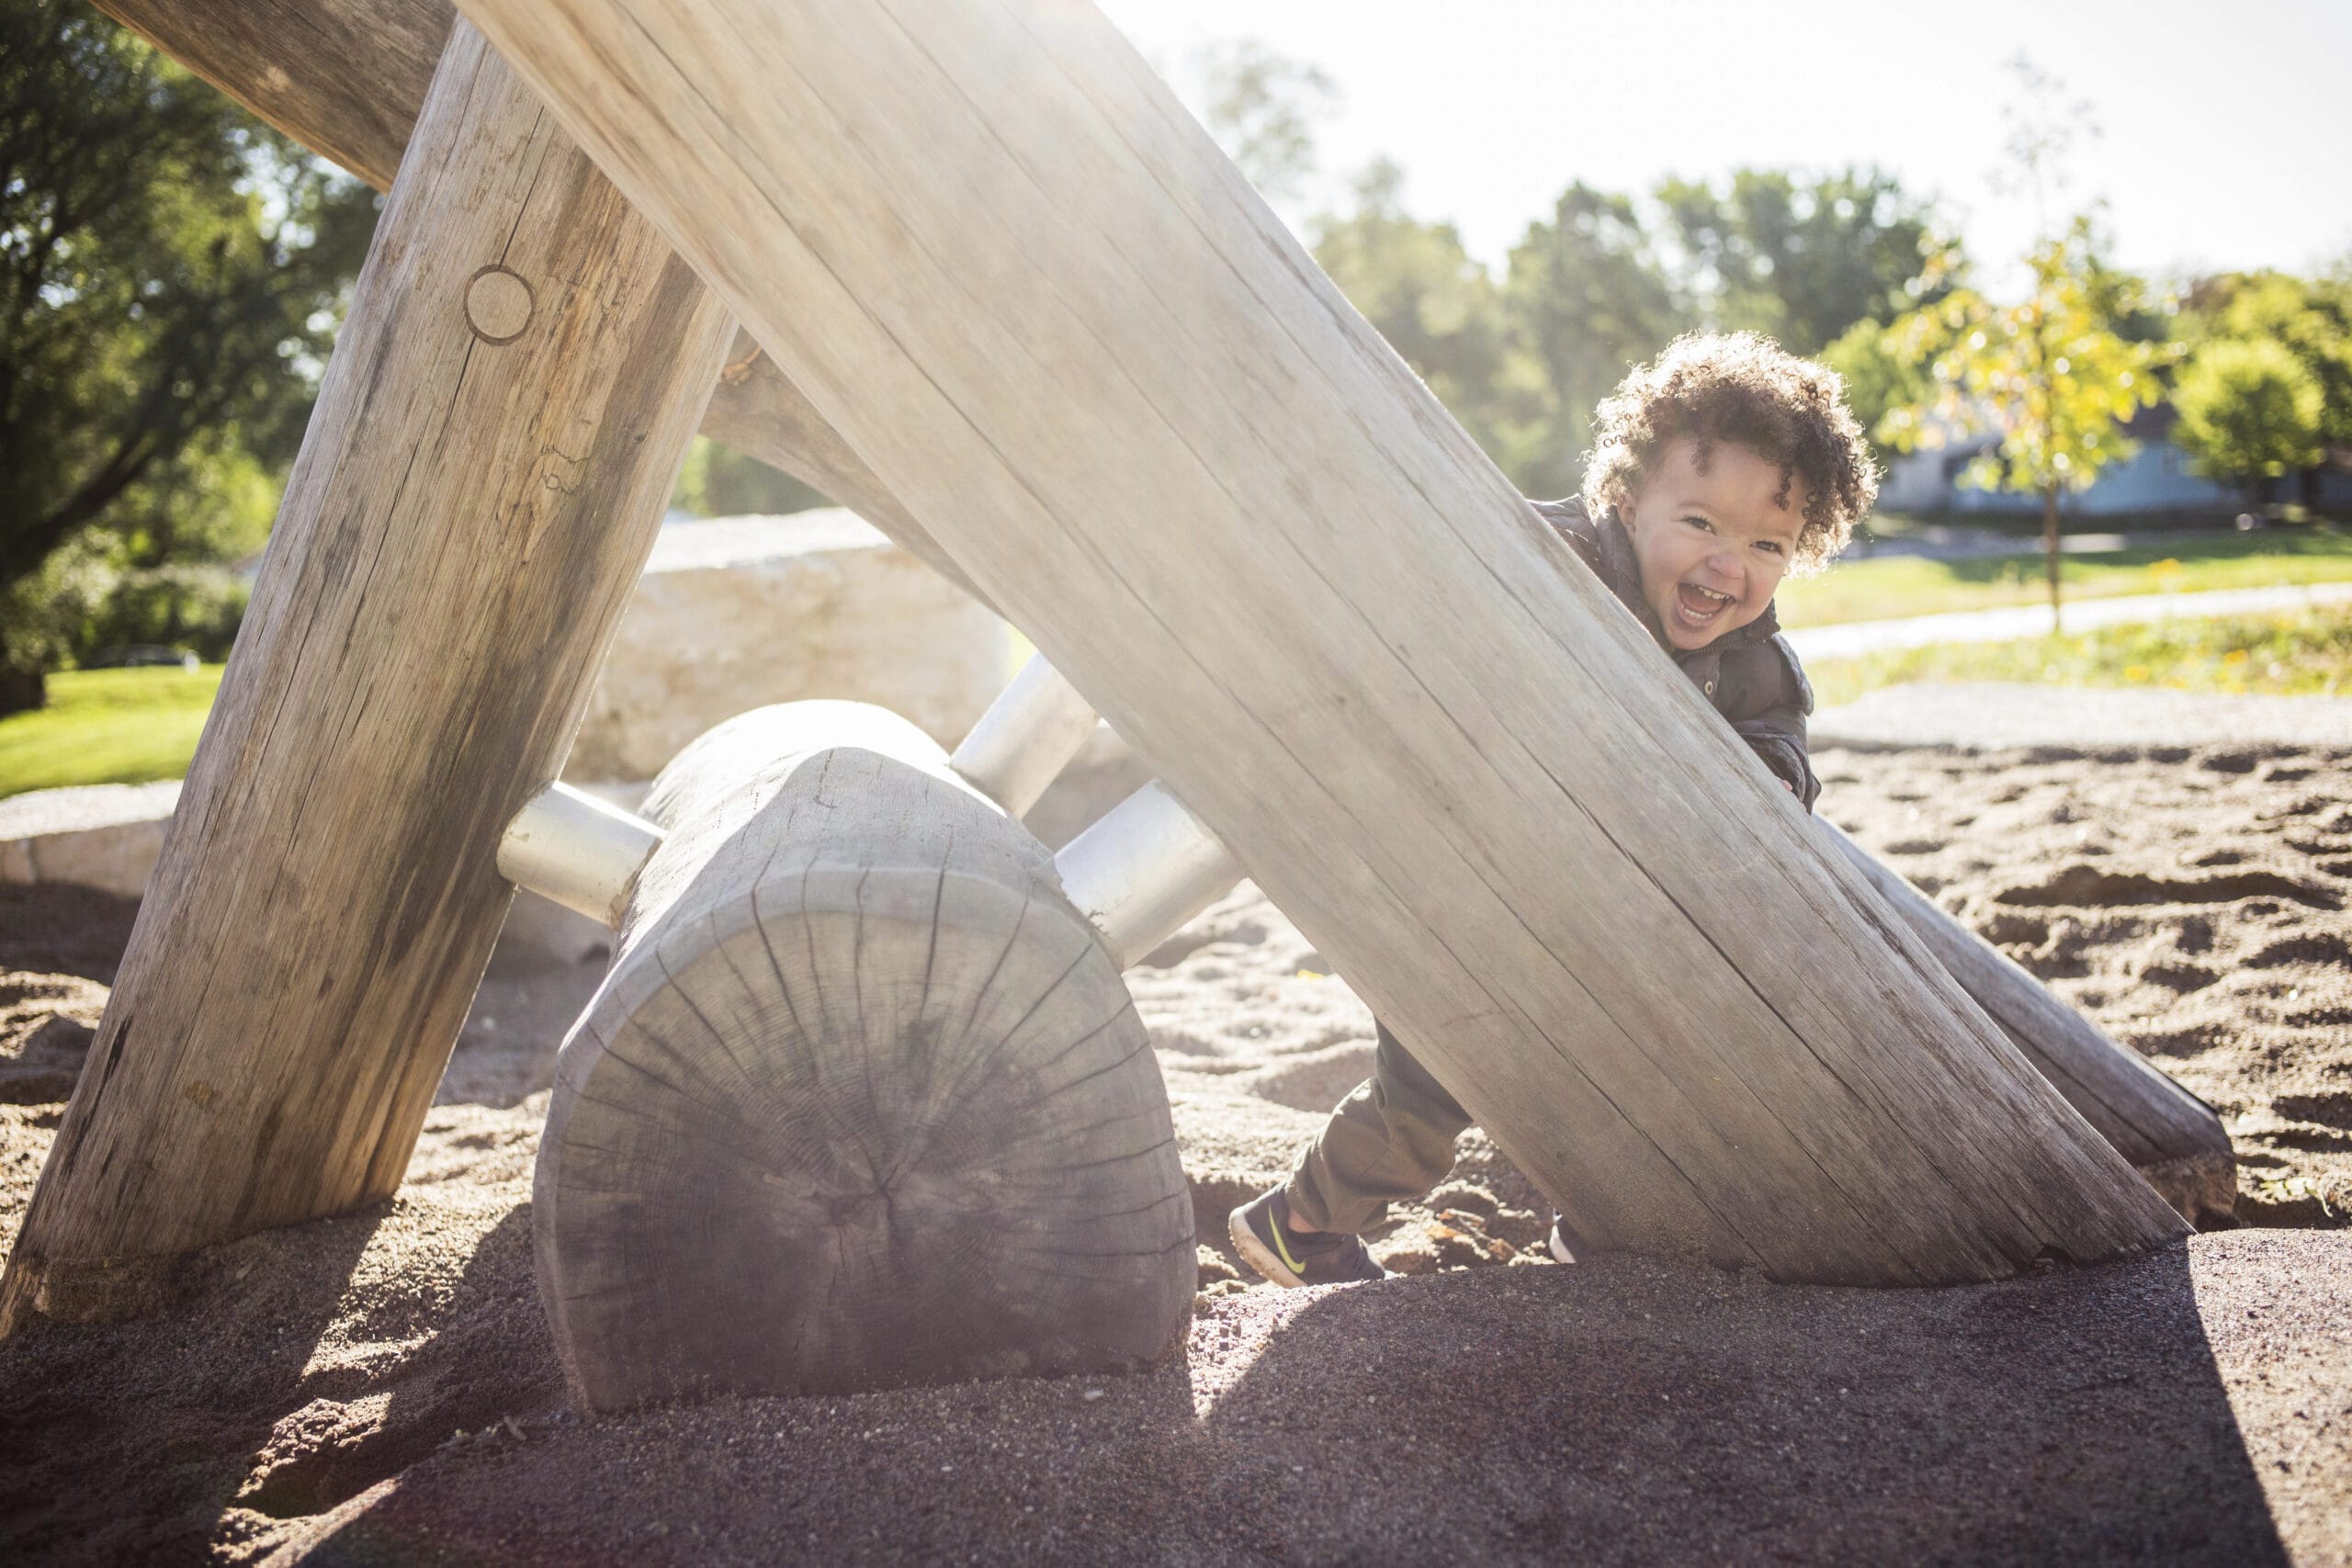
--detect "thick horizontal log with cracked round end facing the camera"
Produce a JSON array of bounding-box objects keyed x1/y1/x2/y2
[{"x1": 532, "y1": 703, "x2": 1194, "y2": 1411}]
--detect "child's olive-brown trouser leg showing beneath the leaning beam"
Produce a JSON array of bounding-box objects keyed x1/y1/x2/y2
[{"x1": 1286, "y1": 1025, "x2": 1470, "y2": 1235}]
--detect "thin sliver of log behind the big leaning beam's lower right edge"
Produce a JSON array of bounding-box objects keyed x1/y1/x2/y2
[{"x1": 1815, "y1": 818, "x2": 2237, "y2": 1224}]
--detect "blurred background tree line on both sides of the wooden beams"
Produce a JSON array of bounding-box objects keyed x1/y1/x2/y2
[{"x1": 0, "y1": 15, "x2": 2352, "y2": 710}]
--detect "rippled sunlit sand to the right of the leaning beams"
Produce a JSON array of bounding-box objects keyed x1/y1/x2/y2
[{"x1": 1815, "y1": 745, "x2": 2352, "y2": 1224}]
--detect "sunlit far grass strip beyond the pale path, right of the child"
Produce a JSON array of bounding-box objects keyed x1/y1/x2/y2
[{"x1": 1778, "y1": 525, "x2": 2352, "y2": 626}]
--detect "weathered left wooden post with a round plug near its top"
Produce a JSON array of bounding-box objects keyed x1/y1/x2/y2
[{"x1": 0, "y1": 17, "x2": 731, "y2": 1328}]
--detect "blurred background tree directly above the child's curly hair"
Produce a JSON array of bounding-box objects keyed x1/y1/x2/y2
[{"x1": 1656, "y1": 167, "x2": 1945, "y2": 355}]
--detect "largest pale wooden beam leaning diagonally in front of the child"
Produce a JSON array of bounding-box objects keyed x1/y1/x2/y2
[{"x1": 461, "y1": 0, "x2": 2183, "y2": 1281}]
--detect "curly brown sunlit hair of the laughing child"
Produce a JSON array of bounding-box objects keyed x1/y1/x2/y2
[{"x1": 1583, "y1": 332, "x2": 1879, "y2": 573}]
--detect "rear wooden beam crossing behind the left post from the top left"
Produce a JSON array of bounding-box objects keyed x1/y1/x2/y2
[{"x1": 99, "y1": 0, "x2": 988, "y2": 602}]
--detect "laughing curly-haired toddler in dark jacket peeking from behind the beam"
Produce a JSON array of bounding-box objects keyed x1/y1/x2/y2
[{"x1": 1227, "y1": 332, "x2": 1877, "y2": 1286}]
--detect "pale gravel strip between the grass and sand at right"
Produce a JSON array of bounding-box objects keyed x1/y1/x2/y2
[{"x1": 1811, "y1": 682, "x2": 2352, "y2": 750}]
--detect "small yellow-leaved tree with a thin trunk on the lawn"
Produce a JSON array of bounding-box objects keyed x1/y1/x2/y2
[{"x1": 1879, "y1": 219, "x2": 2166, "y2": 623}]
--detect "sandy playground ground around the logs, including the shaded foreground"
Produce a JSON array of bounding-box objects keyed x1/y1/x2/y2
[{"x1": 0, "y1": 745, "x2": 2352, "y2": 1563}]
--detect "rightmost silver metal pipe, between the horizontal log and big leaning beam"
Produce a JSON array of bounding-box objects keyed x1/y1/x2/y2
[{"x1": 1054, "y1": 778, "x2": 1242, "y2": 968}]
